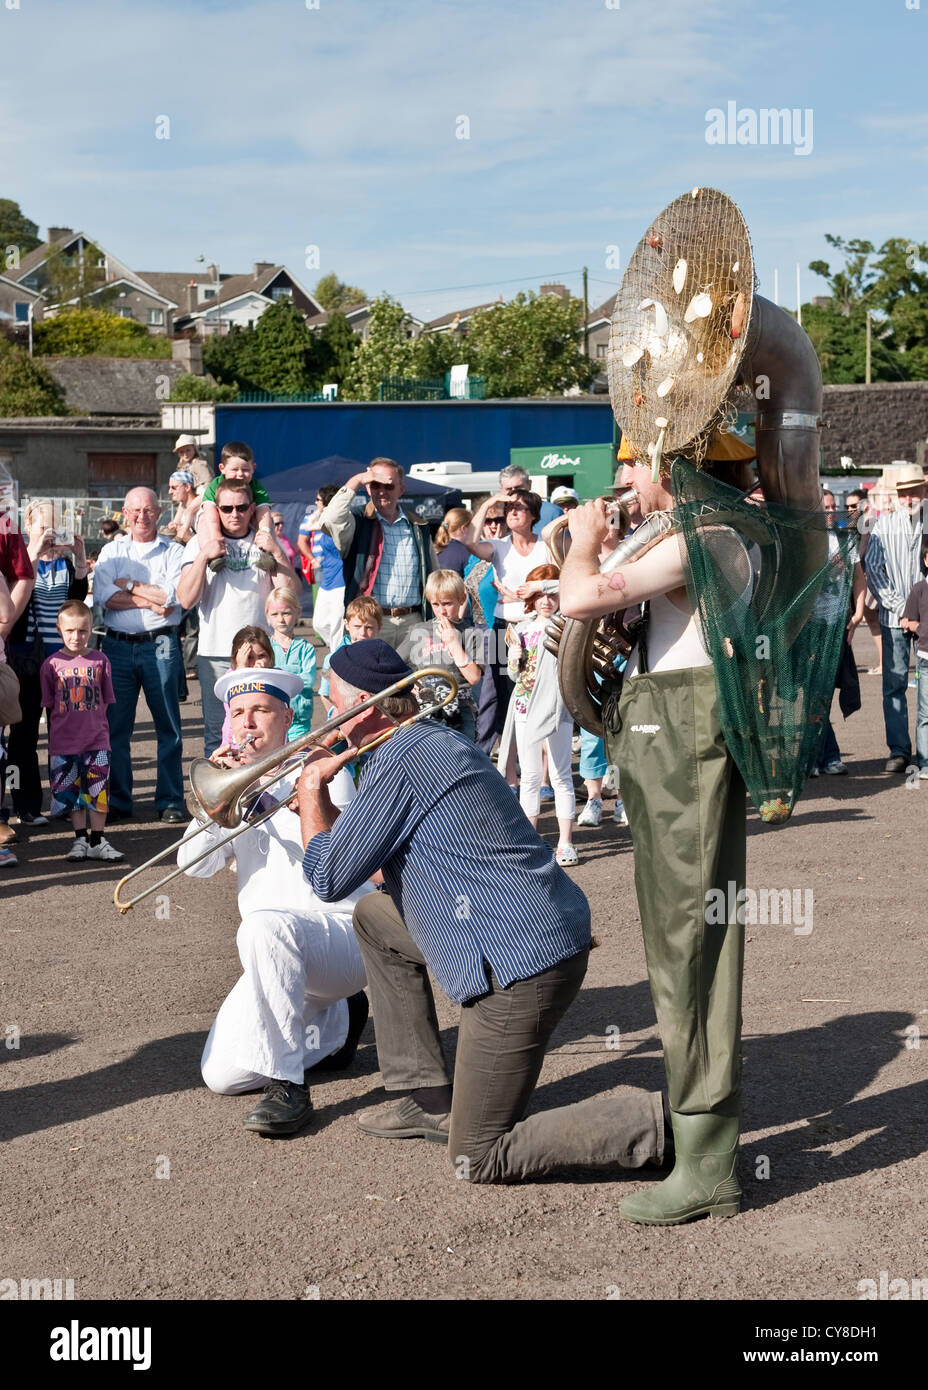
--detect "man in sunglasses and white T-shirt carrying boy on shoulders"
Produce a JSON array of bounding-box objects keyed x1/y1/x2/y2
[{"x1": 178, "y1": 480, "x2": 299, "y2": 758}]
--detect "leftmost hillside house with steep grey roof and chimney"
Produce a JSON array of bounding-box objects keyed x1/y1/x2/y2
[{"x1": 7, "y1": 227, "x2": 174, "y2": 334}]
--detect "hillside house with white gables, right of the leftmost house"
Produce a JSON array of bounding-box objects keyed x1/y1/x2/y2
[{"x1": 143, "y1": 261, "x2": 322, "y2": 338}]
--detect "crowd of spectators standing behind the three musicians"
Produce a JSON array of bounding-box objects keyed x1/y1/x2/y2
[{"x1": 0, "y1": 450, "x2": 928, "y2": 866}]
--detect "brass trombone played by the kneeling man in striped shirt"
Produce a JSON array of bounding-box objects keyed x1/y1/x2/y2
[{"x1": 113, "y1": 666, "x2": 457, "y2": 913}]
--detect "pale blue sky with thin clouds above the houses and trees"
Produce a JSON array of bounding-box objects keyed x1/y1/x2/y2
[{"x1": 0, "y1": 0, "x2": 928, "y2": 318}]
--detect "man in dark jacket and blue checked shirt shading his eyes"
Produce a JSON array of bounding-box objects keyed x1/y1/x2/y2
[{"x1": 322, "y1": 459, "x2": 438, "y2": 652}]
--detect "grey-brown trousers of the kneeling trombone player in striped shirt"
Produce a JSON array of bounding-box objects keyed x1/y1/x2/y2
[{"x1": 354, "y1": 892, "x2": 664, "y2": 1183}]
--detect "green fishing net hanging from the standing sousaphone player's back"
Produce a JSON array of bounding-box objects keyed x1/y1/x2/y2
[{"x1": 671, "y1": 459, "x2": 857, "y2": 824}]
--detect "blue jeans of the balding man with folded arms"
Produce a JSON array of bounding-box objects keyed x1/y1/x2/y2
[{"x1": 103, "y1": 628, "x2": 183, "y2": 812}]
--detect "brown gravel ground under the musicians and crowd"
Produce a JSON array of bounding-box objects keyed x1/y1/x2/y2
[{"x1": 0, "y1": 634, "x2": 928, "y2": 1311}]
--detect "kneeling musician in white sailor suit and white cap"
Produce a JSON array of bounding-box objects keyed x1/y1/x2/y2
[{"x1": 178, "y1": 669, "x2": 372, "y2": 1137}]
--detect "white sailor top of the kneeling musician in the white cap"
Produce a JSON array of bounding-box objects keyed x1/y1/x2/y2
[{"x1": 178, "y1": 769, "x2": 374, "y2": 917}]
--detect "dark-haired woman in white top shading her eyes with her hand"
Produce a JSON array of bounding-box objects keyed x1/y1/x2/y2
[{"x1": 460, "y1": 488, "x2": 550, "y2": 788}]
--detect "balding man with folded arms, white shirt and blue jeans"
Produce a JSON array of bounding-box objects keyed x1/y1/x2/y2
[{"x1": 93, "y1": 488, "x2": 186, "y2": 823}]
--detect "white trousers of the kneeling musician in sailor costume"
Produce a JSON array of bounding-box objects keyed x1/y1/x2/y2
[{"x1": 200, "y1": 909, "x2": 367, "y2": 1095}]
